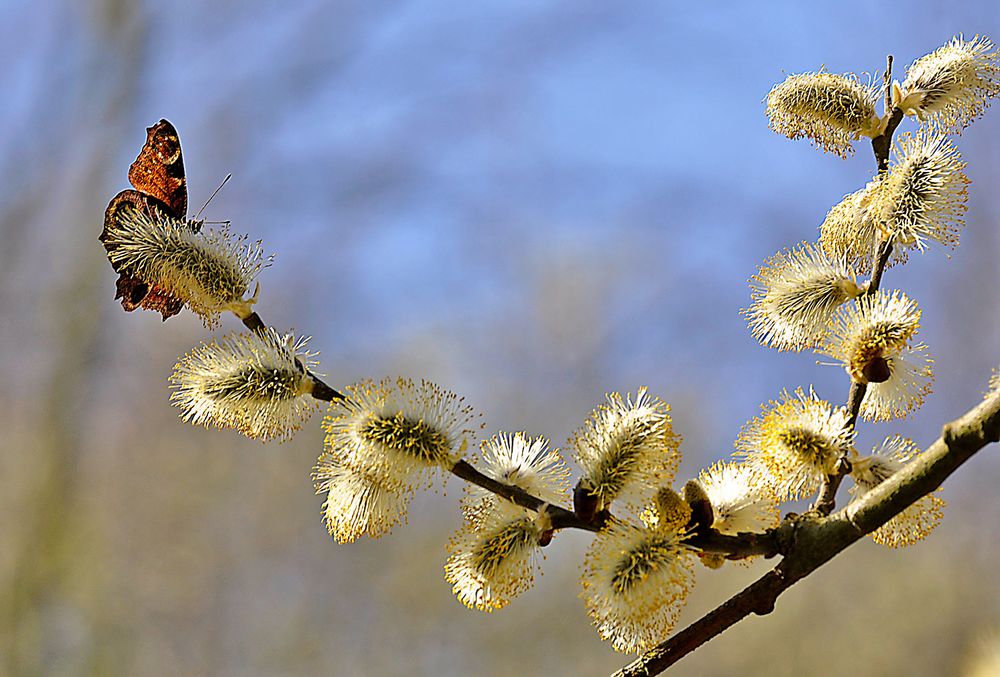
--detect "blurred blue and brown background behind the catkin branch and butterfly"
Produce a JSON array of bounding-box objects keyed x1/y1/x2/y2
[{"x1": 0, "y1": 0, "x2": 1000, "y2": 675}]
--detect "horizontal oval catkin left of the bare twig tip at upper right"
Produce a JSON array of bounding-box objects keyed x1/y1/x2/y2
[{"x1": 766, "y1": 71, "x2": 882, "y2": 157}]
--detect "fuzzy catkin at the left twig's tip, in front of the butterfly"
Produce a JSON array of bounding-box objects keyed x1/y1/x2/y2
[{"x1": 107, "y1": 209, "x2": 270, "y2": 328}]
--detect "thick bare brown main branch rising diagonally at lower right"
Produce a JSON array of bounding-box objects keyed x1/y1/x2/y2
[{"x1": 615, "y1": 390, "x2": 1000, "y2": 677}]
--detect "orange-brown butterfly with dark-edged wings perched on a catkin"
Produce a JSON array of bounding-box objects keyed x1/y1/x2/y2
[{"x1": 99, "y1": 120, "x2": 201, "y2": 320}]
